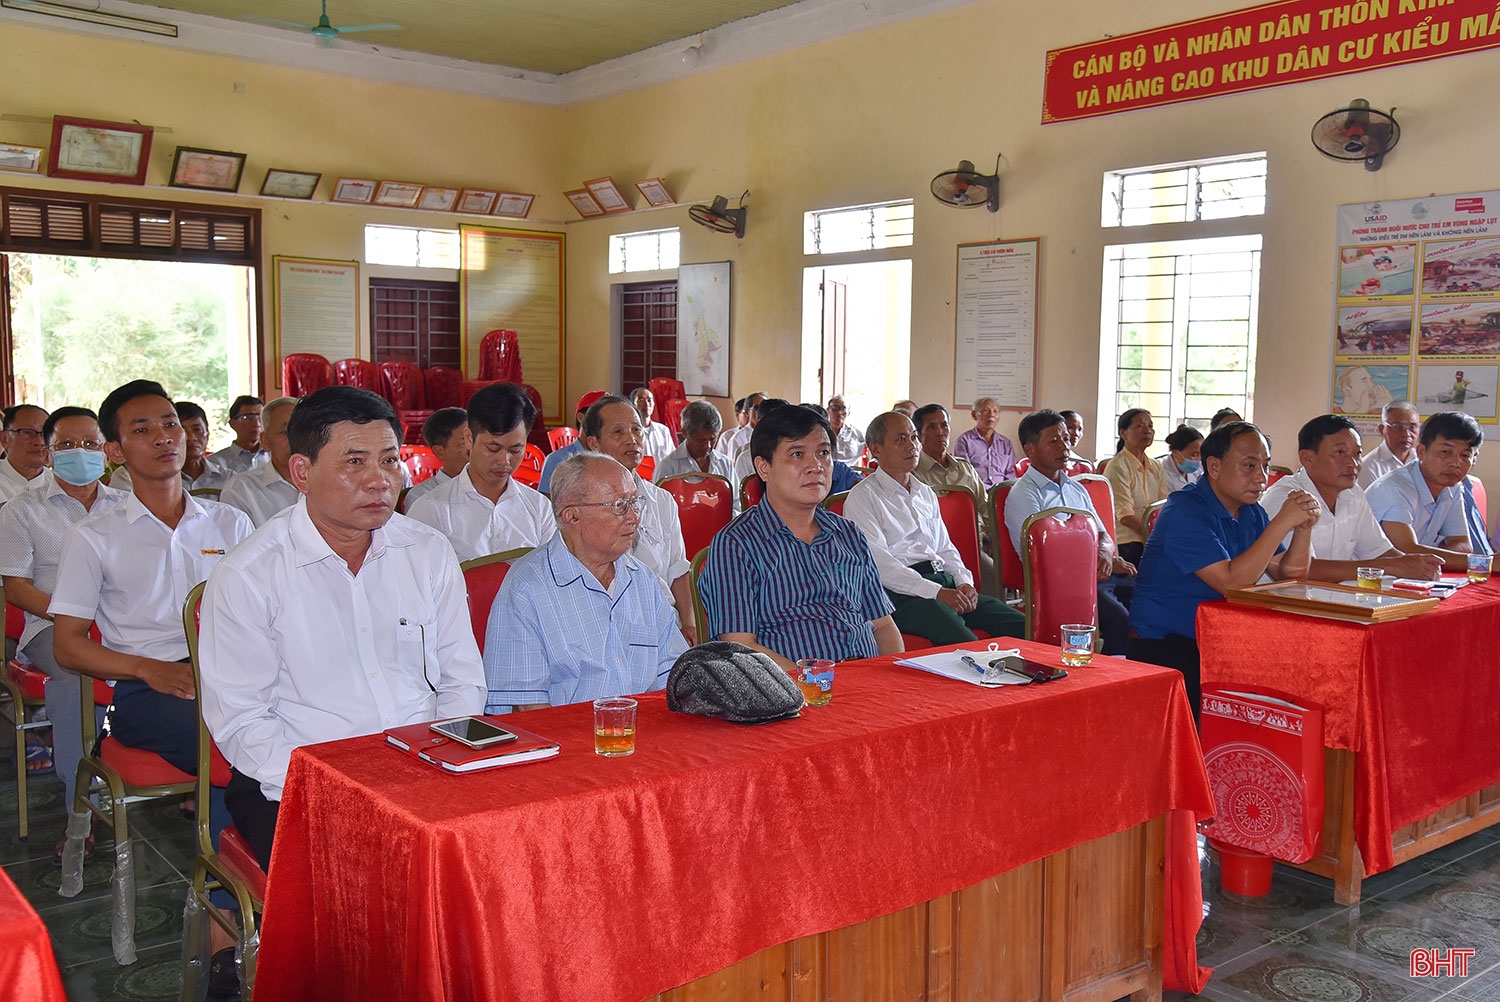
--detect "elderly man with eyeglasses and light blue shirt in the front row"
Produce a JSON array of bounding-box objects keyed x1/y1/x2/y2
[{"x1": 485, "y1": 450, "x2": 687, "y2": 713}]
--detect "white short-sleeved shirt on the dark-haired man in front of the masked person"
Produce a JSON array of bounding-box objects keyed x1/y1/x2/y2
[{"x1": 47, "y1": 494, "x2": 255, "y2": 662}]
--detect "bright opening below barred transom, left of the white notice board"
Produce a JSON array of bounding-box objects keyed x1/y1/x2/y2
[{"x1": 801, "y1": 260, "x2": 912, "y2": 431}]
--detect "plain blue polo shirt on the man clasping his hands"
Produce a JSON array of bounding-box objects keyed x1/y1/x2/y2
[{"x1": 1130, "y1": 480, "x2": 1283, "y2": 641}]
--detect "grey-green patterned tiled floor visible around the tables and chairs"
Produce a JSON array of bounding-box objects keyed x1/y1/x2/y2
[{"x1": 0, "y1": 741, "x2": 1500, "y2": 1002}]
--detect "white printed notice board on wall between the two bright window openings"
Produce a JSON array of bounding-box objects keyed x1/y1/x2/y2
[{"x1": 953, "y1": 237, "x2": 1041, "y2": 411}]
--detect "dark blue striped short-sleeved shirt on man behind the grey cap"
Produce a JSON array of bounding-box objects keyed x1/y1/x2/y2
[{"x1": 699, "y1": 501, "x2": 893, "y2": 662}]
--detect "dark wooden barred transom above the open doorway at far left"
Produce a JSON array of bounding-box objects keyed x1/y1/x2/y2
[{"x1": 0, "y1": 188, "x2": 261, "y2": 267}]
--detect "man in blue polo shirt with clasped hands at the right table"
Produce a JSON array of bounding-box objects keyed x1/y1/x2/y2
[{"x1": 1130, "y1": 422, "x2": 1322, "y2": 719}]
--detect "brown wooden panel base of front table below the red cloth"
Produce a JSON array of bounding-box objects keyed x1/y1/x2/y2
[{"x1": 651, "y1": 818, "x2": 1166, "y2": 1002}]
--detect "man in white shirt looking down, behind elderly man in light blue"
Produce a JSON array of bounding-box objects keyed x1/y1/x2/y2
[{"x1": 407, "y1": 383, "x2": 557, "y2": 561}]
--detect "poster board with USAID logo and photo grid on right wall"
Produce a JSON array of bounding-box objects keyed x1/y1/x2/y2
[{"x1": 1332, "y1": 191, "x2": 1500, "y2": 438}]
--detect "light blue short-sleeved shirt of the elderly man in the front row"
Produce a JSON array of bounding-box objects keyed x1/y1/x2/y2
[{"x1": 485, "y1": 533, "x2": 687, "y2": 713}]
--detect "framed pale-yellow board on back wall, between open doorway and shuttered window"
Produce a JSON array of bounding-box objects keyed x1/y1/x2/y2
[{"x1": 272, "y1": 255, "x2": 360, "y2": 372}]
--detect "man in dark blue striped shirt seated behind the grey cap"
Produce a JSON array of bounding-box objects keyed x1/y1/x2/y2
[{"x1": 701, "y1": 405, "x2": 902, "y2": 669}]
